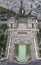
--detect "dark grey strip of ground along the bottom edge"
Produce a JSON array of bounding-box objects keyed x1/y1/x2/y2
[{"x1": 0, "y1": 61, "x2": 41, "y2": 65}]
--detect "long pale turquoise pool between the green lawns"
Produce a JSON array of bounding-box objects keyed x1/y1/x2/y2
[{"x1": 17, "y1": 44, "x2": 26, "y2": 62}]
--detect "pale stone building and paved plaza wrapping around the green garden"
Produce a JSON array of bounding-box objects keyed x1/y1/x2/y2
[{"x1": 3, "y1": 19, "x2": 38, "y2": 61}]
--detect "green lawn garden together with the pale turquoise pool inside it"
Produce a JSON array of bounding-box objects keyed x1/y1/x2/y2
[{"x1": 14, "y1": 42, "x2": 31, "y2": 62}]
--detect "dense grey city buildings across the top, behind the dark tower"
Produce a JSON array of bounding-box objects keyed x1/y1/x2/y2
[{"x1": 0, "y1": 0, "x2": 40, "y2": 13}]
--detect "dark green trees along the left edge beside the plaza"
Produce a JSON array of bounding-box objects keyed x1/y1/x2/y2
[{"x1": 0, "y1": 24, "x2": 8, "y2": 57}]
